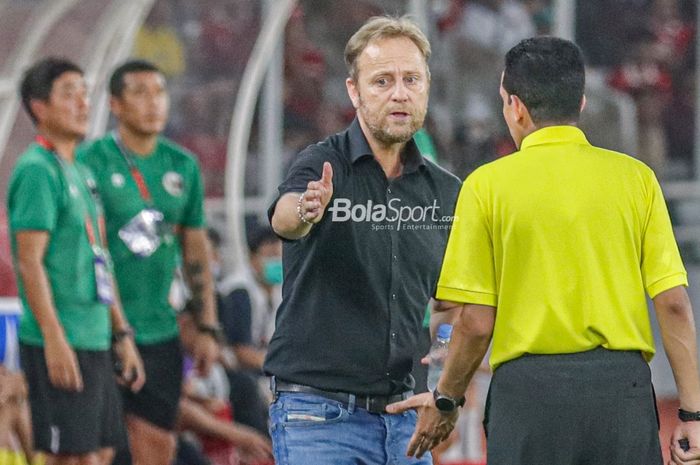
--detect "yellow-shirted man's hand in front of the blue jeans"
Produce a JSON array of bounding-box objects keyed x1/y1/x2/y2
[{"x1": 386, "y1": 392, "x2": 459, "y2": 458}]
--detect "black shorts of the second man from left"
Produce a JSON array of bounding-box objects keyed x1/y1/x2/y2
[{"x1": 122, "y1": 338, "x2": 182, "y2": 431}]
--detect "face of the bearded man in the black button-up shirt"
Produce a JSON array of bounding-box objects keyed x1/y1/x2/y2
[{"x1": 346, "y1": 37, "x2": 430, "y2": 145}]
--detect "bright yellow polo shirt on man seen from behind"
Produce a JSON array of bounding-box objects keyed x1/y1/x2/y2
[{"x1": 437, "y1": 126, "x2": 688, "y2": 368}]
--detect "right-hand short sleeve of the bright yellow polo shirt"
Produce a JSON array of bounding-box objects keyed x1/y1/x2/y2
[{"x1": 641, "y1": 174, "x2": 688, "y2": 298}]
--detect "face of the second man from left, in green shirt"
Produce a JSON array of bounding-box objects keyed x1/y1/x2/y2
[{"x1": 112, "y1": 71, "x2": 169, "y2": 136}]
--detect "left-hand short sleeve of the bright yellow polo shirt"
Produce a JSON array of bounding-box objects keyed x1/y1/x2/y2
[{"x1": 436, "y1": 173, "x2": 498, "y2": 307}]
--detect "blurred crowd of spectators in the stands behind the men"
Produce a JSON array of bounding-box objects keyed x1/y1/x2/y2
[{"x1": 130, "y1": 0, "x2": 696, "y2": 197}]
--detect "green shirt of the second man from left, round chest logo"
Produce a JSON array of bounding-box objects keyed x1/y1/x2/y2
[{"x1": 78, "y1": 134, "x2": 205, "y2": 344}]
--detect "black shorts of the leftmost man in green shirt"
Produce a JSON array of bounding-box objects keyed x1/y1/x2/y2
[{"x1": 20, "y1": 344, "x2": 126, "y2": 455}]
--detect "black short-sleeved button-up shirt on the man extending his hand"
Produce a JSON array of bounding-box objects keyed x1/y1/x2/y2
[{"x1": 264, "y1": 120, "x2": 460, "y2": 395}]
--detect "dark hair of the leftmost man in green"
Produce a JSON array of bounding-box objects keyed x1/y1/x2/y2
[{"x1": 19, "y1": 57, "x2": 83, "y2": 124}]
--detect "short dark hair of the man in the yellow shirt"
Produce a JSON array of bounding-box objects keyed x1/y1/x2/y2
[{"x1": 503, "y1": 37, "x2": 586, "y2": 124}]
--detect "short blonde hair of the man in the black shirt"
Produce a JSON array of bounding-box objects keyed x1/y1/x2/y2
[{"x1": 345, "y1": 16, "x2": 431, "y2": 81}]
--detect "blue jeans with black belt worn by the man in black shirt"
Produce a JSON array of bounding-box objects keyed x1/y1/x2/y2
[{"x1": 270, "y1": 392, "x2": 433, "y2": 465}]
